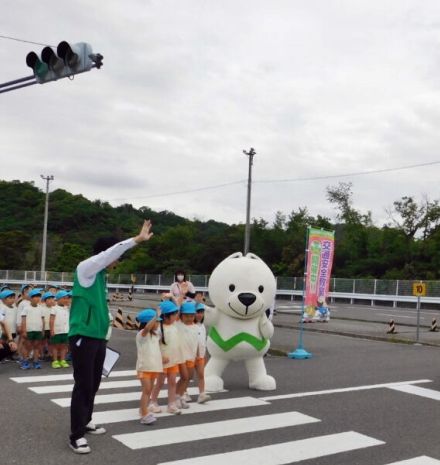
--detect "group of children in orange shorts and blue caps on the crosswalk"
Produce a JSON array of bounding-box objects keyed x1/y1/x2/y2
[{"x1": 136, "y1": 300, "x2": 210, "y2": 425}]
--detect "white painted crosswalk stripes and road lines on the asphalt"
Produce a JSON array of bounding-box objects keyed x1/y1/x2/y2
[{"x1": 10, "y1": 370, "x2": 440, "y2": 465}]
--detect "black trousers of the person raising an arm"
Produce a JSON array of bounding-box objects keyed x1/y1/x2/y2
[{"x1": 69, "y1": 336, "x2": 107, "y2": 441}]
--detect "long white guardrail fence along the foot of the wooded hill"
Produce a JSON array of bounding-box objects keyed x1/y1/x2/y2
[{"x1": 0, "y1": 270, "x2": 440, "y2": 307}]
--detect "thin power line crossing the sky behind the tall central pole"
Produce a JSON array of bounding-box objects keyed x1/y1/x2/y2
[{"x1": 110, "y1": 160, "x2": 440, "y2": 202}]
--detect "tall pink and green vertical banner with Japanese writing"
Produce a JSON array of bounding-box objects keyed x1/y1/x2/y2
[{"x1": 303, "y1": 227, "x2": 335, "y2": 321}]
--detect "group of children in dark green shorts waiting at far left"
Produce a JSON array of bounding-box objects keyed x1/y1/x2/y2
[{"x1": 0, "y1": 284, "x2": 71, "y2": 370}]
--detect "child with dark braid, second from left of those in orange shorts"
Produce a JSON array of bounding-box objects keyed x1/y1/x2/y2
[{"x1": 149, "y1": 300, "x2": 182, "y2": 415}]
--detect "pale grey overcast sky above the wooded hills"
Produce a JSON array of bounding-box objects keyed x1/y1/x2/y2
[{"x1": 0, "y1": 0, "x2": 440, "y2": 225}]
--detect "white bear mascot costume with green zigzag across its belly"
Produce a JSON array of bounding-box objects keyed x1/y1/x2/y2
[{"x1": 205, "y1": 252, "x2": 276, "y2": 392}]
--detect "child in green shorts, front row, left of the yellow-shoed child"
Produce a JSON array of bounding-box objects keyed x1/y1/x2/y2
[{"x1": 20, "y1": 289, "x2": 44, "y2": 370}]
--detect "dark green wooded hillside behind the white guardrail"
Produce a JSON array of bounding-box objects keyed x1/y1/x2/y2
[{"x1": 0, "y1": 180, "x2": 440, "y2": 279}]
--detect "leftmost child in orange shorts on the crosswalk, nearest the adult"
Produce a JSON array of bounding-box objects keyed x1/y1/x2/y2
[{"x1": 136, "y1": 308, "x2": 164, "y2": 425}]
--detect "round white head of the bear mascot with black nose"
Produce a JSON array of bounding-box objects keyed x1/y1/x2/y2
[{"x1": 208, "y1": 252, "x2": 276, "y2": 320}]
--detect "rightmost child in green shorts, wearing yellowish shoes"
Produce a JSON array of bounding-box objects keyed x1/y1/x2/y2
[{"x1": 49, "y1": 291, "x2": 70, "y2": 368}]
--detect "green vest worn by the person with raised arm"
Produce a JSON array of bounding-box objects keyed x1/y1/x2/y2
[{"x1": 69, "y1": 270, "x2": 110, "y2": 339}]
